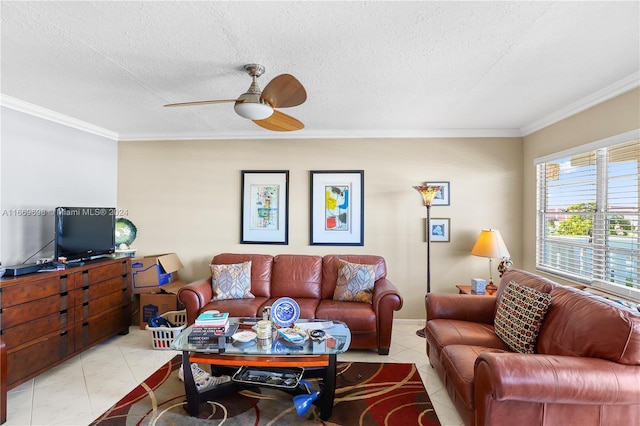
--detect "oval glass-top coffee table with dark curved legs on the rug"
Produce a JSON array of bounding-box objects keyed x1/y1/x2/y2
[{"x1": 171, "y1": 318, "x2": 351, "y2": 420}]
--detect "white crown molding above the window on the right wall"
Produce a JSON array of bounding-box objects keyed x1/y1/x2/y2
[{"x1": 520, "y1": 72, "x2": 640, "y2": 136}]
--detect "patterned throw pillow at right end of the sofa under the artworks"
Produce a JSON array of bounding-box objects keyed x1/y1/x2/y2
[{"x1": 333, "y1": 260, "x2": 376, "y2": 303}]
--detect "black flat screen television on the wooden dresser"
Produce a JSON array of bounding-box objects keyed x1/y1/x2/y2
[{"x1": 54, "y1": 207, "x2": 116, "y2": 262}]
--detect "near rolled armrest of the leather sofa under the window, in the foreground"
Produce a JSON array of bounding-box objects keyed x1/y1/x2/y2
[{"x1": 475, "y1": 353, "x2": 640, "y2": 407}]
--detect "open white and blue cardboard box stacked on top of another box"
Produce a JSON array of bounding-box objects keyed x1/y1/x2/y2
[{"x1": 131, "y1": 253, "x2": 183, "y2": 294}]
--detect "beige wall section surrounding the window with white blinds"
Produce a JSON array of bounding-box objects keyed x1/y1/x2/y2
[{"x1": 522, "y1": 89, "x2": 640, "y2": 279}]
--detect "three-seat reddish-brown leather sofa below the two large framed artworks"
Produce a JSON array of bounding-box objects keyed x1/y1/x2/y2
[{"x1": 178, "y1": 253, "x2": 402, "y2": 355}]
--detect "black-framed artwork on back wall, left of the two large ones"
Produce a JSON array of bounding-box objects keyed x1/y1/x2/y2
[{"x1": 240, "y1": 170, "x2": 289, "y2": 244}]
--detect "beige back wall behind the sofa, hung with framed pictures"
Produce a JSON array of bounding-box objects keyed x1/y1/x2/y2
[{"x1": 118, "y1": 138, "x2": 523, "y2": 319}]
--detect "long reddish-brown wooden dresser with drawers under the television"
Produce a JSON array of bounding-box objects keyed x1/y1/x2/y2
[{"x1": 0, "y1": 257, "x2": 131, "y2": 401}]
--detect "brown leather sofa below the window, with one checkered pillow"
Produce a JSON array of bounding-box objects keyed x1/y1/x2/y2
[{"x1": 426, "y1": 270, "x2": 640, "y2": 426}]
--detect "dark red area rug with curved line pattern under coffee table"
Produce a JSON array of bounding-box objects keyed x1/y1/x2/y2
[{"x1": 91, "y1": 355, "x2": 440, "y2": 426}]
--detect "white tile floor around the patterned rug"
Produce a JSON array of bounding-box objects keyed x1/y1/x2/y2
[{"x1": 5, "y1": 320, "x2": 463, "y2": 426}]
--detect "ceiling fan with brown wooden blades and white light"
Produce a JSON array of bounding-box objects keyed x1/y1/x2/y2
[{"x1": 165, "y1": 64, "x2": 307, "y2": 132}]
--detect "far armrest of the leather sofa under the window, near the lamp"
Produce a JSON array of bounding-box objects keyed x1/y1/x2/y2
[{"x1": 425, "y1": 293, "x2": 496, "y2": 324}]
